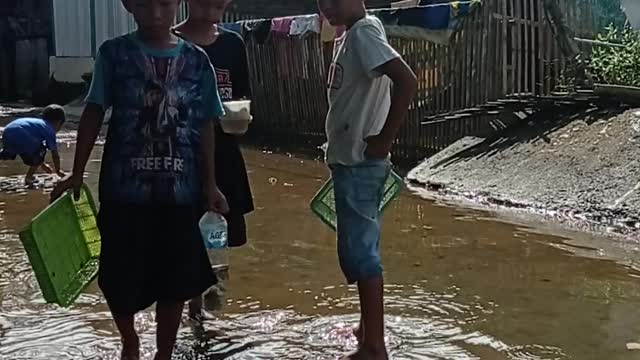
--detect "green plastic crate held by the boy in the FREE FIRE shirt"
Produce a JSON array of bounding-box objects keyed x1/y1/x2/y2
[{"x1": 20, "y1": 186, "x2": 100, "y2": 307}]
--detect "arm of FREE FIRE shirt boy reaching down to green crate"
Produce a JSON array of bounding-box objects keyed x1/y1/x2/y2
[{"x1": 51, "y1": 103, "x2": 104, "y2": 201}]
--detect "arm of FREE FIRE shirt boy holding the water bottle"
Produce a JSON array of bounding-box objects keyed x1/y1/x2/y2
[{"x1": 200, "y1": 121, "x2": 229, "y2": 214}]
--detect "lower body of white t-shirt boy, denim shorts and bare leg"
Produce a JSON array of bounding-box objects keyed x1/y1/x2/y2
[{"x1": 332, "y1": 162, "x2": 390, "y2": 359}]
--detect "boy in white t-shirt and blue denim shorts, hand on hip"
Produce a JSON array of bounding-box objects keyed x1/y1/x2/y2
[{"x1": 318, "y1": 0, "x2": 417, "y2": 360}]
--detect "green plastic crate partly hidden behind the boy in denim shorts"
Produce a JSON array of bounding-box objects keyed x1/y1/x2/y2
[{"x1": 311, "y1": 171, "x2": 404, "y2": 231}]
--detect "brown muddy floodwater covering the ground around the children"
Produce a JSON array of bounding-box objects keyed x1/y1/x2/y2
[{"x1": 0, "y1": 147, "x2": 640, "y2": 360}]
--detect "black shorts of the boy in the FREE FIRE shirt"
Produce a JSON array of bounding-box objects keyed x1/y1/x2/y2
[{"x1": 98, "y1": 203, "x2": 217, "y2": 315}]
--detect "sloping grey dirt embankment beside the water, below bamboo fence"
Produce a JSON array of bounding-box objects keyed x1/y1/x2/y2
[{"x1": 409, "y1": 105, "x2": 640, "y2": 238}]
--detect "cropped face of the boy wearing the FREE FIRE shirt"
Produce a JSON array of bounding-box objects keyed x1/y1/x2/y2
[{"x1": 122, "y1": 0, "x2": 181, "y2": 35}]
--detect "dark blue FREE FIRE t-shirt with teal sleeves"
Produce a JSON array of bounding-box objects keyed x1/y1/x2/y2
[{"x1": 87, "y1": 33, "x2": 224, "y2": 205}]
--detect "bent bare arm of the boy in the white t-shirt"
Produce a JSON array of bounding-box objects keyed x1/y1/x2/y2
[{"x1": 366, "y1": 58, "x2": 418, "y2": 159}]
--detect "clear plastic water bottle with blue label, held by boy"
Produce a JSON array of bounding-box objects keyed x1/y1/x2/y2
[{"x1": 199, "y1": 211, "x2": 229, "y2": 311}]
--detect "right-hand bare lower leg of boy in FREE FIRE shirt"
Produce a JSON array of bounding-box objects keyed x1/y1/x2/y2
[{"x1": 154, "y1": 302, "x2": 184, "y2": 360}]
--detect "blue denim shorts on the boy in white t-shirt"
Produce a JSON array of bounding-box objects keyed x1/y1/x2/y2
[{"x1": 330, "y1": 160, "x2": 391, "y2": 284}]
